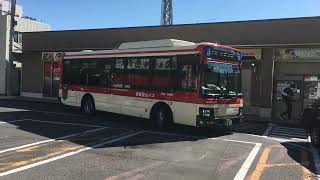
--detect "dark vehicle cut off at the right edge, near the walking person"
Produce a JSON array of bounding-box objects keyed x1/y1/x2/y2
[{"x1": 301, "y1": 99, "x2": 320, "y2": 147}]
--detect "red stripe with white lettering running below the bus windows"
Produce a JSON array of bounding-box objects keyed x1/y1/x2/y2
[{"x1": 60, "y1": 85, "x2": 242, "y2": 104}]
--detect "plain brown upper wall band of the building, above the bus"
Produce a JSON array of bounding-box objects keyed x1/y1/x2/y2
[{"x1": 23, "y1": 17, "x2": 320, "y2": 51}]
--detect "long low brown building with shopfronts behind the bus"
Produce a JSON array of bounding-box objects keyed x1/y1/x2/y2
[{"x1": 21, "y1": 17, "x2": 320, "y2": 123}]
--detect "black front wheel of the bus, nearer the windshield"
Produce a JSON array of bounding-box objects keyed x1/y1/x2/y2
[{"x1": 151, "y1": 106, "x2": 173, "y2": 129}]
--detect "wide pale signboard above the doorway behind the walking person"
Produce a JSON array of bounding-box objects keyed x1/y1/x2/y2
[{"x1": 274, "y1": 48, "x2": 320, "y2": 60}]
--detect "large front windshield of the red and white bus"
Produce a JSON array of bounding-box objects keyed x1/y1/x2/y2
[{"x1": 201, "y1": 61, "x2": 241, "y2": 97}]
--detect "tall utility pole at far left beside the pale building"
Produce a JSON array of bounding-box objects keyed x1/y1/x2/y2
[{"x1": 6, "y1": 0, "x2": 16, "y2": 96}]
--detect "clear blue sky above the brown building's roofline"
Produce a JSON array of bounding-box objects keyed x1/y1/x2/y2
[{"x1": 16, "y1": 0, "x2": 320, "y2": 30}]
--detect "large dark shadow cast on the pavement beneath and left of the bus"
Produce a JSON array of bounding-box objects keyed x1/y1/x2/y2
[{"x1": 0, "y1": 101, "x2": 230, "y2": 149}]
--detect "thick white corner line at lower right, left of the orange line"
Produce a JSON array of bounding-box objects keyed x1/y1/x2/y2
[{"x1": 234, "y1": 140, "x2": 262, "y2": 180}]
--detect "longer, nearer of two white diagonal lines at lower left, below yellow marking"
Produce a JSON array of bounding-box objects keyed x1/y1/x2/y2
[{"x1": 0, "y1": 131, "x2": 144, "y2": 177}]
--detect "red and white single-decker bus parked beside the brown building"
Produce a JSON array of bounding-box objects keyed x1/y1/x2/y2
[{"x1": 59, "y1": 39, "x2": 243, "y2": 128}]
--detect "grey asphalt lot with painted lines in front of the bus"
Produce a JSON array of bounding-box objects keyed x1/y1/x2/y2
[{"x1": 0, "y1": 100, "x2": 319, "y2": 180}]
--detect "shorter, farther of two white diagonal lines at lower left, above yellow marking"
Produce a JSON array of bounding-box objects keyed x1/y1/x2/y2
[{"x1": 0, "y1": 127, "x2": 108, "y2": 154}]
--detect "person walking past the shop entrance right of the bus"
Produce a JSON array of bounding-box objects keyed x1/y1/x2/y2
[{"x1": 280, "y1": 84, "x2": 296, "y2": 120}]
